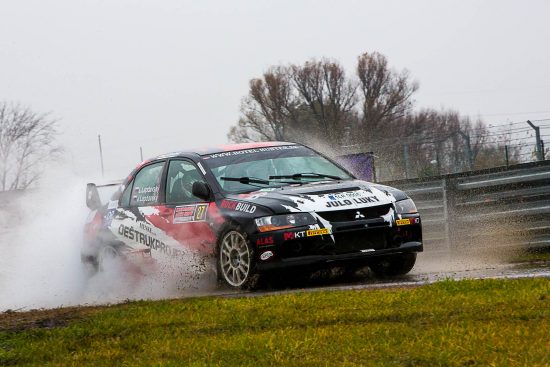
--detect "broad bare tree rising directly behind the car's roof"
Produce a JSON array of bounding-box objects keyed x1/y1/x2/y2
[{"x1": 228, "y1": 60, "x2": 357, "y2": 152}]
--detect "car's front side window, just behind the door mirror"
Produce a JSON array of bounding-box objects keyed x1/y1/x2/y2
[{"x1": 166, "y1": 160, "x2": 206, "y2": 204}]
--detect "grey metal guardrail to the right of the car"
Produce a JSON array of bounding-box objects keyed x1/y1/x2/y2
[{"x1": 384, "y1": 161, "x2": 550, "y2": 251}]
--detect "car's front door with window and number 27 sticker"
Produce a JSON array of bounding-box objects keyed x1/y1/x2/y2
[{"x1": 147, "y1": 159, "x2": 220, "y2": 254}]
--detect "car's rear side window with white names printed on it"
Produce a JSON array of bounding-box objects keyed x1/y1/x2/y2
[{"x1": 130, "y1": 162, "x2": 164, "y2": 206}]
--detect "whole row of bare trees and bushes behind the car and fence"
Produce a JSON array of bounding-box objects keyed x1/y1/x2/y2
[{"x1": 228, "y1": 52, "x2": 532, "y2": 180}]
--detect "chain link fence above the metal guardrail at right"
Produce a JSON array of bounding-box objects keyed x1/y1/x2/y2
[{"x1": 372, "y1": 119, "x2": 550, "y2": 181}]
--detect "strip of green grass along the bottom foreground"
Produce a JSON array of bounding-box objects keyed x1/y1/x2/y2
[{"x1": 0, "y1": 279, "x2": 550, "y2": 366}]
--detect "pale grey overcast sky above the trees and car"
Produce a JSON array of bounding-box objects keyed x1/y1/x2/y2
[{"x1": 0, "y1": 0, "x2": 550, "y2": 181}]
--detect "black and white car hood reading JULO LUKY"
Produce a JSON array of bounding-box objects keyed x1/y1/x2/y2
[{"x1": 227, "y1": 180, "x2": 406, "y2": 214}]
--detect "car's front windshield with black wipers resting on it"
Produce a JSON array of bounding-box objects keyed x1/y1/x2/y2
[{"x1": 202, "y1": 145, "x2": 352, "y2": 193}]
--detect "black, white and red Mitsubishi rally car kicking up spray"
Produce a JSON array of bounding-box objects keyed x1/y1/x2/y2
[{"x1": 82, "y1": 142, "x2": 423, "y2": 288}]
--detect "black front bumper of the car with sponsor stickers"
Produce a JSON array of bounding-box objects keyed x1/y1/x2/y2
[{"x1": 251, "y1": 214, "x2": 423, "y2": 271}]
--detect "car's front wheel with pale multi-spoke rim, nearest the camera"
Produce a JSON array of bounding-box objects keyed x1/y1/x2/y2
[{"x1": 216, "y1": 226, "x2": 259, "y2": 289}]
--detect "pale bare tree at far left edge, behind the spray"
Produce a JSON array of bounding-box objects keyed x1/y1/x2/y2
[{"x1": 0, "y1": 102, "x2": 59, "y2": 191}]
